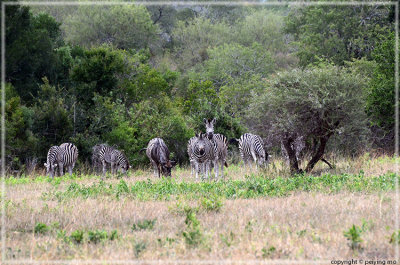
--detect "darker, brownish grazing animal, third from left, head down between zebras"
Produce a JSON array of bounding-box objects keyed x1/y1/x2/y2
[{"x1": 145, "y1": 138, "x2": 176, "y2": 177}]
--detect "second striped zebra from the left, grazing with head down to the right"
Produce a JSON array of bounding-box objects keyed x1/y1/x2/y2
[{"x1": 92, "y1": 144, "x2": 131, "y2": 176}]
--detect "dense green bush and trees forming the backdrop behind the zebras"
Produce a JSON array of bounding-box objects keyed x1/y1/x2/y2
[{"x1": 6, "y1": 1, "x2": 394, "y2": 173}]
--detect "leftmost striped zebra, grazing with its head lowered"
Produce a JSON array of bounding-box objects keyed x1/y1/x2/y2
[{"x1": 44, "y1": 143, "x2": 78, "y2": 178}]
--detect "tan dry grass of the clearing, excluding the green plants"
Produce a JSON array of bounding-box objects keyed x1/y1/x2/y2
[{"x1": 1, "y1": 156, "x2": 396, "y2": 264}]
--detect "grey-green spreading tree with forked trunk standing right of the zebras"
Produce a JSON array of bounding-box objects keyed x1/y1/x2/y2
[{"x1": 248, "y1": 65, "x2": 367, "y2": 173}]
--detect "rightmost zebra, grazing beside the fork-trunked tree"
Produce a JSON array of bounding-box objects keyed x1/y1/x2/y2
[{"x1": 230, "y1": 133, "x2": 268, "y2": 169}]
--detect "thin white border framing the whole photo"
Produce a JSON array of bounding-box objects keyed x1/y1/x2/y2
[{"x1": 0, "y1": 1, "x2": 400, "y2": 264}]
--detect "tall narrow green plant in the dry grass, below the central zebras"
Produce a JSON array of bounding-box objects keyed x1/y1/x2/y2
[{"x1": 182, "y1": 207, "x2": 203, "y2": 247}]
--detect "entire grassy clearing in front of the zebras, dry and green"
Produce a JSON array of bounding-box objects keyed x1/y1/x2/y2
[{"x1": 5, "y1": 157, "x2": 400, "y2": 264}]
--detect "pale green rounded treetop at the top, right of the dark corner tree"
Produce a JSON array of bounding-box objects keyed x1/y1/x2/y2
[{"x1": 62, "y1": 5, "x2": 159, "y2": 50}]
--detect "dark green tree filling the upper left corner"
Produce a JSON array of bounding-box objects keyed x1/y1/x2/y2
[{"x1": 6, "y1": 6, "x2": 66, "y2": 102}]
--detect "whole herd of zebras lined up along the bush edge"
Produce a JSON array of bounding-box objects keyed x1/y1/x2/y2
[{"x1": 44, "y1": 118, "x2": 268, "y2": 177}]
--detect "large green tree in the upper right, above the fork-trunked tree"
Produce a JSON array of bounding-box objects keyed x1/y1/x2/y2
[{"x1": 285, "y1": 6, "x2": 390, "y2": 67}]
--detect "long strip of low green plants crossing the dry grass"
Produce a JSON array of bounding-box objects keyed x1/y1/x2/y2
[{"x1": 30, "y1": 173, "x2": 396, "y2": 200}]
